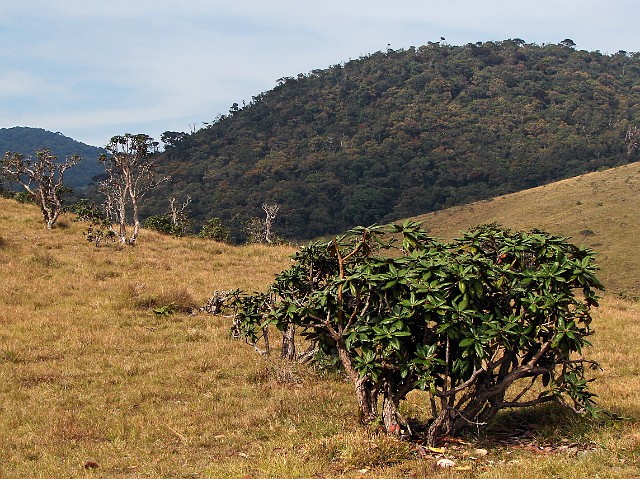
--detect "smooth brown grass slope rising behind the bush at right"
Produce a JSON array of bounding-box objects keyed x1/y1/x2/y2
[{"x1": 414, "y1": 163, "x2": 640, "y2": 298}]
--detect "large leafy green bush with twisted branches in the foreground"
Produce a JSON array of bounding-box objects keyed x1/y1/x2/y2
[{"x1": 235, "y1": 222, "x2": 602, "y2": 443}]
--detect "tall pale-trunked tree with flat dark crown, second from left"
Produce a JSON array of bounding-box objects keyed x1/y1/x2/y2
[{"x1": 100, "y1": 133, "x2": 169, "y2": 245}]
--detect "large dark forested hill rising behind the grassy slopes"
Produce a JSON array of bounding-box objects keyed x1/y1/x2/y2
[{"x1": 150, "y1": 39, "x2": 640, "y2": 238}]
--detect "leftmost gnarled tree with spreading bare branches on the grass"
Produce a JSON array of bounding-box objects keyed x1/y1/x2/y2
[{"x1": 0, "y1": 149, "x2": 80, "y2": 230}]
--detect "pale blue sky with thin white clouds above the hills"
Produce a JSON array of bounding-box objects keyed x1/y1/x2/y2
[{"x1": 0, "y1": 0, "x2": 640, "y2": 146}]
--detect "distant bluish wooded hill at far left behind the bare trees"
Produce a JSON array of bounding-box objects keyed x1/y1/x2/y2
[{"x1": 0, "y1": 126, "x2": 106, "y2": 188}]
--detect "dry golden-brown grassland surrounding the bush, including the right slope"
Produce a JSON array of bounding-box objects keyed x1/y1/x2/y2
[{"x1": 0, "y1": 166, "x2": 640, "y2": 479}]
